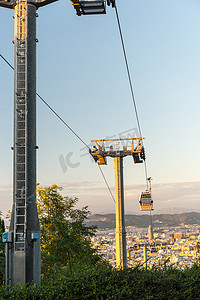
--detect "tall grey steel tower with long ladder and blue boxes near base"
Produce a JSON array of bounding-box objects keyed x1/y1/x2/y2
[{"x1": 0, "y1": 0, "x2": 56, "y2": 285}]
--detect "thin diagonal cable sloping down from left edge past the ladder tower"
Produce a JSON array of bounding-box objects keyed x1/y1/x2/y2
[{"x1": 0, "y1": 54, "x2": 115, "y2": 202}]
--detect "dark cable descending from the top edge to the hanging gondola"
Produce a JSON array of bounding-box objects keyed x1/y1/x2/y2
[{"x1": 115, "y1": 4, "x2": 148, "y2": 189}]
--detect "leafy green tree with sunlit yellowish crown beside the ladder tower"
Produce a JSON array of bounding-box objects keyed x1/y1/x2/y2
[{"x1": 37, "y1": 184, "x2": 100, "y2": 273}]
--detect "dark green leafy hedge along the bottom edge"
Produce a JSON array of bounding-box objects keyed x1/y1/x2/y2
[{"x1": 0, "y1": 264, "x2": 200, "y2": 300}]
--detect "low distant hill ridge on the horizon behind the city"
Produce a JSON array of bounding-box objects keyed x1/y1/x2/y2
[{"x1": 86, "y1": 212, "x2": 200, "y2": 229}]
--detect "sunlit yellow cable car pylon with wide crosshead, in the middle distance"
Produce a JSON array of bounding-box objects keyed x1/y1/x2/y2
[{"x1": 90, "y1": 138, "x2": 145, "y2": 269}]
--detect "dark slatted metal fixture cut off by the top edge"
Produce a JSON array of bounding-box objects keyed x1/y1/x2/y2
[{"x1": 71, "y1": 0, "x2": 106, "y2": 16}]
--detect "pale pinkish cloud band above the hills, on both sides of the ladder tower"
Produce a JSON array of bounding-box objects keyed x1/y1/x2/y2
[{"x1": 0, "y1": 181, "x2": 200, "y2": 215}]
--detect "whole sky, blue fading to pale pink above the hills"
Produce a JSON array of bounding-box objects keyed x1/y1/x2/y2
[{"x1": 0, "y1": 0, "x2": 200, "y2": 215}]
